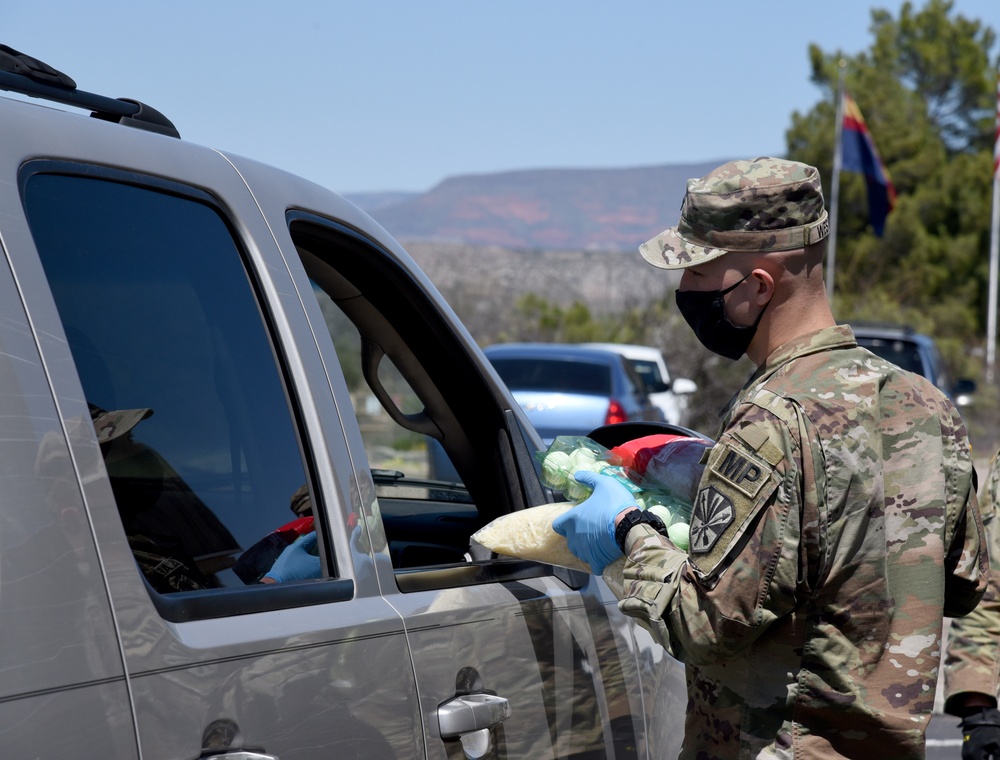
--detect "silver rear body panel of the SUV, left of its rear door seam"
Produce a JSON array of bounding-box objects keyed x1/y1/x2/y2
[{"x1": 0, "y1": 154, "x2": 138, "y2": 760}]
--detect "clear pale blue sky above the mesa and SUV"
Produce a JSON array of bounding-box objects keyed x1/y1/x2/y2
[{"x1": 0, "y1": 0, "x2": 1000, "y2": 193}]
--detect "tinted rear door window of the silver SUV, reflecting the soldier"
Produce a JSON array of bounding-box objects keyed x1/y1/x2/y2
[{"x1": 23, "y1": 170, "x2": 330, "y2": 594}]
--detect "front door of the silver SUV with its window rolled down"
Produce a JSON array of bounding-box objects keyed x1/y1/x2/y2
[{"x1": 238, "y1": 163, "x2": 682, "y2": 758}]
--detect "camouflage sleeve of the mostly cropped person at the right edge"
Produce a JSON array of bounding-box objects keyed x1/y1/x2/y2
[{"x1": 944, "y1": 452, "x2": 1000, "y2": 714}]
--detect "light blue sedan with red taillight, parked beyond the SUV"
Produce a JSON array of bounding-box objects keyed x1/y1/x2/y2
[{"x1": 483, "y1": 343, "x2": 664, "y2": 446}]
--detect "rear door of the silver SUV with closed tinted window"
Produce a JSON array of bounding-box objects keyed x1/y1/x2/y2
[{"x1": 7, "y1": 108, "x2": 423, "y2": 760}]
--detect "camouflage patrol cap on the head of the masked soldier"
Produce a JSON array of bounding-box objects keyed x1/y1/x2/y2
[{"x1": 639, "y1": 156, "x2": 830, "y2": 269}]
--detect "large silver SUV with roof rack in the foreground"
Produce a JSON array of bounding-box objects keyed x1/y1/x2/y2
[{"x1": 0, "y1": 47, "x2": 685, "y2": 760}]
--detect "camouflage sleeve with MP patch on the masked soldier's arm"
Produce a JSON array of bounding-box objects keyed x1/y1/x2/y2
[{"x1": 604, "y1": 404, "x2": 800, "y2": 665}]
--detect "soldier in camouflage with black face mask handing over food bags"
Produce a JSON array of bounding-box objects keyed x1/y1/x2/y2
[{"x1": 553, "y1": 158, "x2": 988, "y2": 760}]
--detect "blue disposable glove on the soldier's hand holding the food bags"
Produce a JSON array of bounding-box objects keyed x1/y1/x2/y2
[{"x1": 552, "y1": 470, "x2": 636, "y2": 575}]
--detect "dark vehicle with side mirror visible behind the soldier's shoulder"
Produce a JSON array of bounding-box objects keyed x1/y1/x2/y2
[{"x1": 851, "y1": 322, "x2": 976, "y2": 407}]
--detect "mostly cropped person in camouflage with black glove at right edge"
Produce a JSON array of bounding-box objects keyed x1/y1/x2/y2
[{"x1": 944, "y1": 452, "x2": 1000, "y2": 760}]
